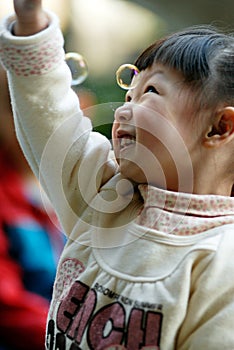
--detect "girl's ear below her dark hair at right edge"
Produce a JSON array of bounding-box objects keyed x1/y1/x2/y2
[{"x1": 203, "y1": 107, "x2": 234, "y2": 148}]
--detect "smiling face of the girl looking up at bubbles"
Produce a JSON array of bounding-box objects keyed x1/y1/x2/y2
[{"x1": 112, "y1": 63, "x2": 204, "y2": 191}]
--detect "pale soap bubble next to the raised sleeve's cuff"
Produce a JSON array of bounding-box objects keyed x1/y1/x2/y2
[{"x1": 65, "y1": 52, "x2": 88, "y2": 86}]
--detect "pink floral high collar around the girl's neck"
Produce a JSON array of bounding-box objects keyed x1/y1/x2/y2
[{"x1": 137, "y1": 185, "x2": 234, "y2": 235}]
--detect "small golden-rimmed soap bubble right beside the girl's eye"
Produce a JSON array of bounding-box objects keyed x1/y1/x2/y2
[{"x1": 116, "y1": 63, "x2": 140, "y2": 90}]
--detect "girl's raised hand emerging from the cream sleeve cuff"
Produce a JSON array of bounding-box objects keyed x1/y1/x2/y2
[{"x1": 13, "y1": 0, "x2": 48, "y2": 36}]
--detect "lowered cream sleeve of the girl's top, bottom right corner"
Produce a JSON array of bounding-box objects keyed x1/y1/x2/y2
[{"x1": 176, "y1": 225, "x2": 234, "y2": 350}]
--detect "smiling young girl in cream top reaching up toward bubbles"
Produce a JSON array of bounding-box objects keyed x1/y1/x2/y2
[{"x1": 1, "y1": 0, "x2": 234, "y2": 350}]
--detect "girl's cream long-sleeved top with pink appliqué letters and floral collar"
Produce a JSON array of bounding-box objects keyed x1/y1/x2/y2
[{"x1": 0, "y1": 10, "x2": 234, "y2": 350}]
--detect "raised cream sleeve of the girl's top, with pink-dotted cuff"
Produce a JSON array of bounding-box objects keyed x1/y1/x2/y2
[{"x1": 0, "y1": 12, "x2": 116, "y2": 235}]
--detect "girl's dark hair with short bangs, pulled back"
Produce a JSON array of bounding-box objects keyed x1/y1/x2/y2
[{"x1": 134, "y1": 26, "x2": 234, "y2": 108}]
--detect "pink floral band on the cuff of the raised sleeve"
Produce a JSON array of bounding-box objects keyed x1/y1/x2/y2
[{"x1": 1, "y1": 31, "x2": 64, "y2": 76}]
